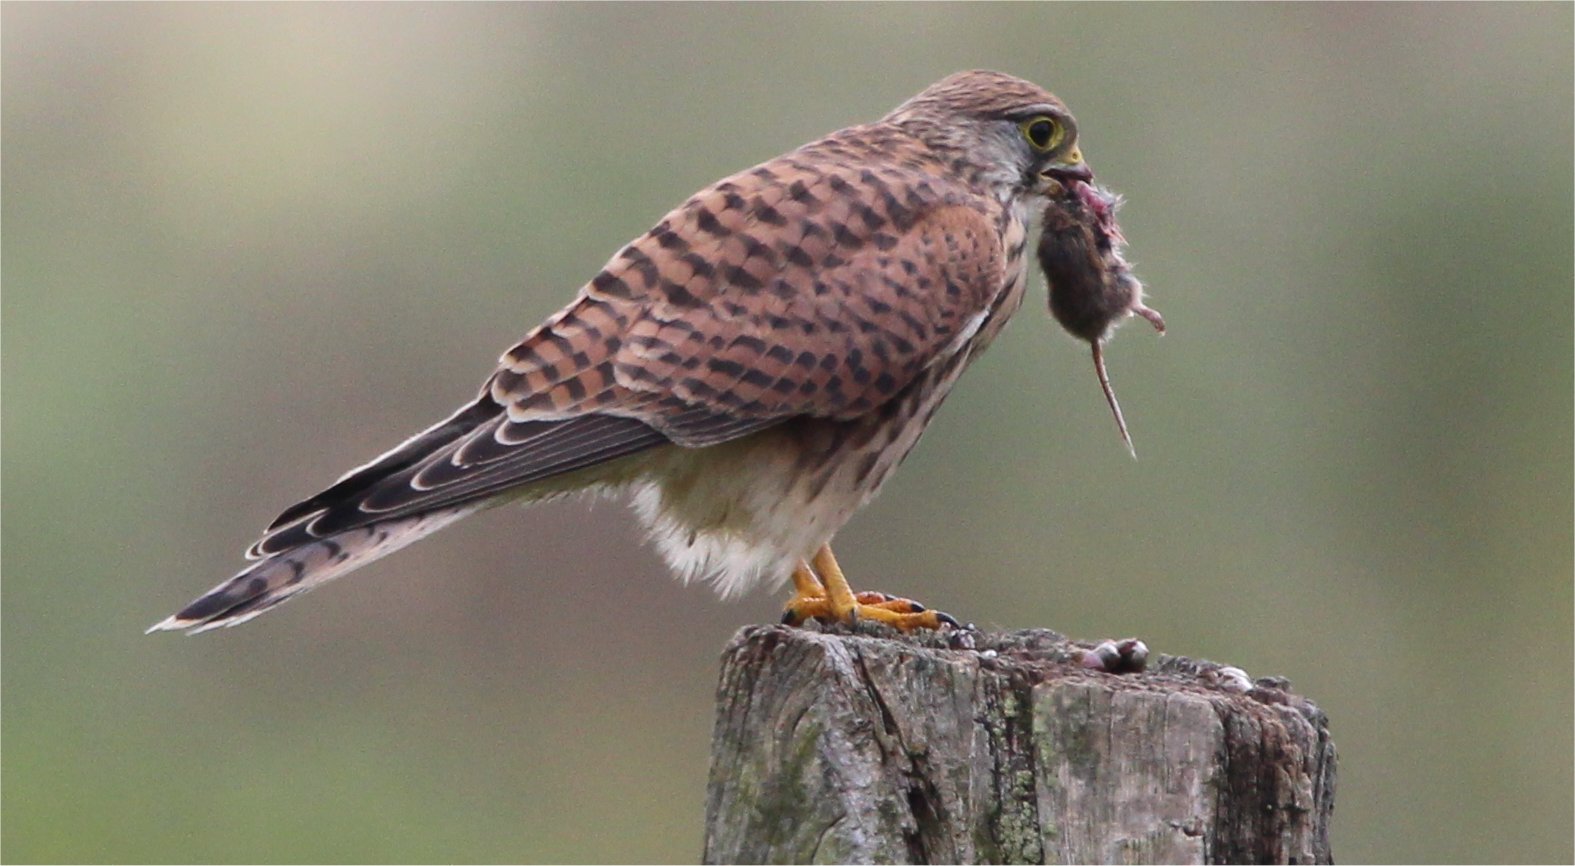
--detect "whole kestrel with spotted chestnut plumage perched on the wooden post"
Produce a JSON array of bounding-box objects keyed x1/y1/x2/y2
[{"x1": 153, "y1": 71, "x2": 1146, "y2": 631}]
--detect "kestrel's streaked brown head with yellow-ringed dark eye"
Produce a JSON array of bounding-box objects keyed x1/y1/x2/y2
[{"x1": 885, "y1": 69, "x2": 1093, "y2": 202}]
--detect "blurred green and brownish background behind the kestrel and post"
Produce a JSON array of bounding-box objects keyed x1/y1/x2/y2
[{"x1": 0, "y1": 3, "x2": 1575, "y2": 861}]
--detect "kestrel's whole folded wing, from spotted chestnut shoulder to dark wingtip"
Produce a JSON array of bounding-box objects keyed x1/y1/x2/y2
[{"x1": 250, "y1": 156, "x2": 1005, "y2": 557}]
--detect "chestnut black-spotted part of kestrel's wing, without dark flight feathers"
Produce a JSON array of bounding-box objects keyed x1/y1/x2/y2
[{"x1": 491, "y1": 154, "x2": 1005, "y2": 434}]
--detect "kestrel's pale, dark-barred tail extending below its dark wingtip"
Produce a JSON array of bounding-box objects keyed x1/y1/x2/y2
[{"x1": 148, "y1": 504, "x2": 484, "y2": 635}]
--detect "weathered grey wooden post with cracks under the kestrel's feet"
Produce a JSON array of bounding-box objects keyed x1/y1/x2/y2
[{"x1": 704, "y1": 625, "x2": 1336, "y2": 863}]
